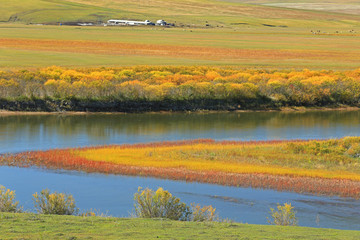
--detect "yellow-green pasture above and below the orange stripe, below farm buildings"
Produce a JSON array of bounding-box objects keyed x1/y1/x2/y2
[{"x1": 0, "y1": 23, "x2": 360, "y2": 69}]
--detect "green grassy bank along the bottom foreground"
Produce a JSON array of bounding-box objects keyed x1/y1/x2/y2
[{"x1": 0, "y1": 213, "x2": 360, "y2": 240}]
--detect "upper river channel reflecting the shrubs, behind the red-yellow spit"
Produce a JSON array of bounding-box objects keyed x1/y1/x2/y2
[{"x1": 0, "y1": 111, "x2": 360, "y2": 153}]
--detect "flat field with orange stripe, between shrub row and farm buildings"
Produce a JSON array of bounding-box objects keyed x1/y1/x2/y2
[{"x1": 0, "y1": 24, "x2": 360, "y2": 69}]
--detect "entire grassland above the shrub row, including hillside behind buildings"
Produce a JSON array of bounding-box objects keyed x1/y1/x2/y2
[{"x1": 0, "y1": 0, "x2": 360, "y2": 69}]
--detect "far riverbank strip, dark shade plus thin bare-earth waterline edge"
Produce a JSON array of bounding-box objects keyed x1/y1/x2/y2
[{"x1": 0, "y1": 99, "x2": 360, "y2": 116}]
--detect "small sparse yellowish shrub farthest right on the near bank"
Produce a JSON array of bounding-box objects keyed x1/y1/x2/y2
[{"x1": 268, "y1": 203, "x2": 298, "y2": 226}]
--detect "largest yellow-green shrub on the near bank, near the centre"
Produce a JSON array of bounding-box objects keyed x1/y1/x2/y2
[{"x1": 134, "y1": 188, "x2": 191, "y2": 221}]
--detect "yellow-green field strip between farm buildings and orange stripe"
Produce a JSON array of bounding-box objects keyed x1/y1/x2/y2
[{"x1": 0, "y1": 24, "x2": 360, "y2": 52}]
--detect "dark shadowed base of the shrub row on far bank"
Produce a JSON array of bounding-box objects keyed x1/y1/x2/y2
[{"x1": 0, "y1": 99, "x2": 279, "y2": 113}]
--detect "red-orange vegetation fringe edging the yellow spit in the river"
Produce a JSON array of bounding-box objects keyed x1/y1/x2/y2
[{"x1": 0, "y1": 140, "x2": 360, "y2": 199}]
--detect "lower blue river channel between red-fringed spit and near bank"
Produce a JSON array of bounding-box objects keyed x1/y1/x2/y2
[{"x1": 0, "y1": 167, "x2": 360, "y2": 230}]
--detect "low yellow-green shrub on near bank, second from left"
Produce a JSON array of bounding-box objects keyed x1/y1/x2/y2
[{"x1": 33, "y1": 189, "x2": 79, "y2": 215}]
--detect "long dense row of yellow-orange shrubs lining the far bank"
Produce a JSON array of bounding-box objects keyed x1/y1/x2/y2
[{"x1": 0, "y1": 66, "x2": 360, "y2": 107}]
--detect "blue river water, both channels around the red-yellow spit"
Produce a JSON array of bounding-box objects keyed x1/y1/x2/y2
[{"x1": 0, "y1": 111, "x2": 360, "y2": 230}]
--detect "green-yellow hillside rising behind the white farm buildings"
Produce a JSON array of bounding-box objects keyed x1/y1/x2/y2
[{"x1": 0, "y1": 0, "x2": 360, "y2": 27}]
